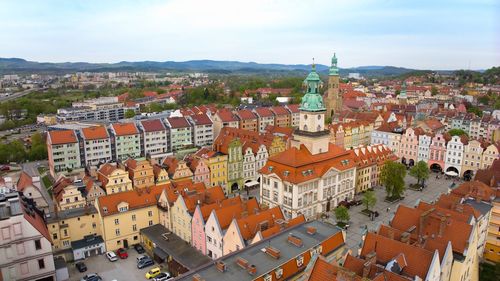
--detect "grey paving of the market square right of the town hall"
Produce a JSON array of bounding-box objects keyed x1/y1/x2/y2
[{"x1": 329, "y1": 173, "x2": 458, "y2": 255}]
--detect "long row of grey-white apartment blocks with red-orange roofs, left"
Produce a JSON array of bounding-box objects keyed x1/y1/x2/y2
[{"x1": 47, "y1": 114, "x2": 214, "y2": 175}]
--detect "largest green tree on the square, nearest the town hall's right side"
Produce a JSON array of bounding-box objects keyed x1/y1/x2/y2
[{"x1": 380, "y1": 161, "x2": 406, "y2": 199}]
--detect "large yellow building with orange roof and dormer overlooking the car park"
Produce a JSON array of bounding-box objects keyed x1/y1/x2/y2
[{"x1": 96, "y1": 186, "x2": 164, "y2": 248}]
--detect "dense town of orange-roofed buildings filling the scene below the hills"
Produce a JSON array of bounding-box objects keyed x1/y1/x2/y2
[{"x1": 0, "y1": 56, "x2": 500, "y2": 281}]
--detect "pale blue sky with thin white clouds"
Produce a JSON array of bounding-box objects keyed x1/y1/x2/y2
[{"x1": 0, "y1": 0, "x2": 500, "y2": 70}]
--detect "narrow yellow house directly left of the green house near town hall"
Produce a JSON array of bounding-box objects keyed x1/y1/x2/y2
[{"x1": 195, "y1": 148, "x2": 228, "y2": 187}]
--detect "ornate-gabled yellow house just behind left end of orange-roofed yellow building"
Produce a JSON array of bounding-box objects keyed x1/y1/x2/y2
[{"x1": 97, "y1": 163, "x2": 133, "y2": 194}]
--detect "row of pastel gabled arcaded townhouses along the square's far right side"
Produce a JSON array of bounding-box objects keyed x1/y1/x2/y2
[{"x1": 371, "y1": 122, "x2": 500, "y2": 179}]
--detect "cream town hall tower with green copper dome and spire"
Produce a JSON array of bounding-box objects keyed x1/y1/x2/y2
[{"x1": 292, "y1": 61, "x2": 330, "y2": 154}]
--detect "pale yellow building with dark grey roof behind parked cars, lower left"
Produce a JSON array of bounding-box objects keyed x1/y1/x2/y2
[{"x1": 47, "y1": 206, "x2": 102, "y2": 261}]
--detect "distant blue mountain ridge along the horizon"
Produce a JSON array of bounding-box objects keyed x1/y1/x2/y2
[{"x1": 0, "y1": 58, "x2": 436, "y2": 76}]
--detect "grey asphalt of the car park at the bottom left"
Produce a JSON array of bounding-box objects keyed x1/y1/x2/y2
[{"x1": 68, "y1": 249, "x2": 169, "y2": 281}]
